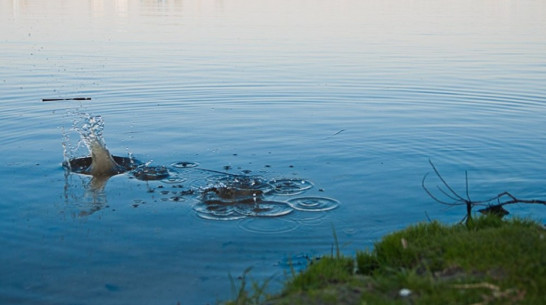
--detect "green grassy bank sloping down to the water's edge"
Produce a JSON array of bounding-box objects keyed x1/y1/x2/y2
[{"x1": 223, "y1": 216, "x2": 546, "y2": 305}]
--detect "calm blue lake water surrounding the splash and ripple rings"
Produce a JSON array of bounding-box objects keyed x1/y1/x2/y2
[{"x1": 0, "y1": 0, "x2": 546, "y2": 304}]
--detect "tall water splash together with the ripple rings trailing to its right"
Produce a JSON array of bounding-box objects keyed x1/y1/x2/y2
[{"x1": 63, "y1": 113, "x2": 339, "y2": 220}]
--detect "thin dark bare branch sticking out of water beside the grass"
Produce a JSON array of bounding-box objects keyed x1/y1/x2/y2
[{"x1": 421, "y1": 160, "x2": 546, "y2": 223}]
